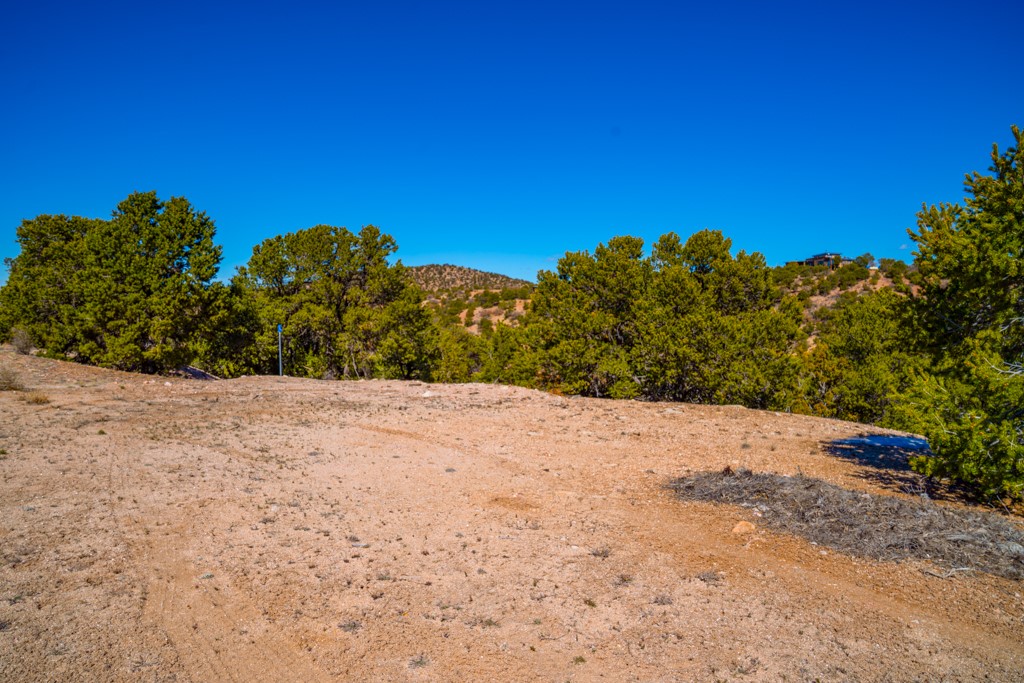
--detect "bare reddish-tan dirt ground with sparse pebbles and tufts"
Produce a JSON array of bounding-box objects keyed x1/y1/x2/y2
[{"x1": 0, "y1": 347, "x2": 1024, "y2": 682}]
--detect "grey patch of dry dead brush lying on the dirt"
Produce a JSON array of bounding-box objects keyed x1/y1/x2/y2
[{"x1": 670, "y1": 467, "x2": 1024, "y2": 579}]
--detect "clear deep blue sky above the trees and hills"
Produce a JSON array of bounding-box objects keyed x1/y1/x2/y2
[{"x1": 0, "y1": 0, "x2": 1024, "y2": 280}]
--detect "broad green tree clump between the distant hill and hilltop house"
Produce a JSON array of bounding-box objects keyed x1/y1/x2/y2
[{"x1": 523, "y1": 230, "x2": 801, "y2": 408}]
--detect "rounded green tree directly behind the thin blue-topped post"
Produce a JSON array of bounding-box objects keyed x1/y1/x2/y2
[{"x1": 237, "y1": 225, "x2": 436, "y2": 379}]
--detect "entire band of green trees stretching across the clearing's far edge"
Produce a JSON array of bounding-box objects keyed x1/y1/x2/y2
[{"x1": 0, "y1": 127, "x2": 1024, "y2": 498}]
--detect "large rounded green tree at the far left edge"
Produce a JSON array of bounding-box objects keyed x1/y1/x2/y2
[{"x1": 0, "y1": 191, "x2": 220, "y2": 372}]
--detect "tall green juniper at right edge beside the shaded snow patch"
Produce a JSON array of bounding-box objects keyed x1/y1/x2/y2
[{"x1": 909, "y1": 126, "x2": 1024, "y2": 498}]
